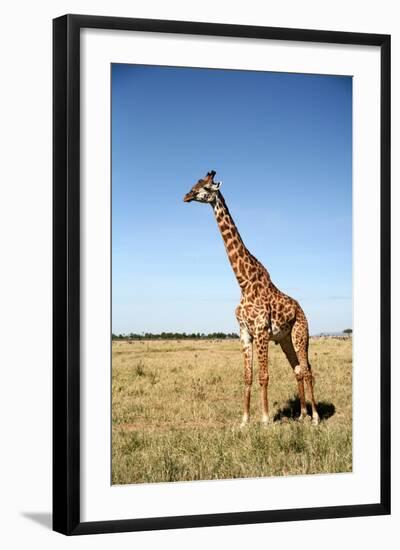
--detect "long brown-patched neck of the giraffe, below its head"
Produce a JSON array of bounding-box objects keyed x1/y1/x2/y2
[{"x1": 212, "y1": 192, "x2": 267, "y2": 290}]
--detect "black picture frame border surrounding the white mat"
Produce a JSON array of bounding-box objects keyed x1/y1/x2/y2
[{"x1": 53, "y1": 15, "x2": 390, "y2": 535}]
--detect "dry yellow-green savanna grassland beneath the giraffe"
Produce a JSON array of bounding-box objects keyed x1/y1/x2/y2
[{"x1": 112, "y1": 338, "x2": 352, "y2": 484}]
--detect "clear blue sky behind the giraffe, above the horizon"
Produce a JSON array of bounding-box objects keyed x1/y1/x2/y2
[{"x1": 112, "y1": 65, "x2": 352, "y2": 334}]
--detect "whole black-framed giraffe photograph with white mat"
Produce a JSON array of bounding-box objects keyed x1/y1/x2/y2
[{"x1": 53, "y1": 15, "x2": 390, "y2": 535}]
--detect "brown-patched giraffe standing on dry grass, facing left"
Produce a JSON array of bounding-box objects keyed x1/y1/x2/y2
[{"x1": 183, "y1": 170, "x2": 319, "y2": 427}]
